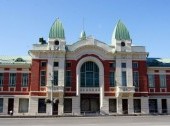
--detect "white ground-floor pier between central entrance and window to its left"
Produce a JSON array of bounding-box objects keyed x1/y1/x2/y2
[{"x1": 72, "y1": 95, "x2": 80, "y2": 115}]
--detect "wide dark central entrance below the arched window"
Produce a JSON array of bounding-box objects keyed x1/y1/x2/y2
[{"x1": 81, "y1": 94, "x2": 100, "y2": 113}]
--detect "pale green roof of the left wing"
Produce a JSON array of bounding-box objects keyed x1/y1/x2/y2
[{"x1": 0, "y1": 56, "x2": 31, "y2": 65}]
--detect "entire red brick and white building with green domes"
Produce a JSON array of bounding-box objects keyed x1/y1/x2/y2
[{"x1": 0, "y1": 19, "x2": 170, "y2": 116}]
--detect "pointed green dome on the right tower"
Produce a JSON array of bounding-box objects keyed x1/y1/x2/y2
[{"x1": 112, "y1": 20, "x2": 131, "y2": 41}]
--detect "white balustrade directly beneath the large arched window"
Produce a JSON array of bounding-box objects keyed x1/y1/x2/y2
[{"x1": 80, "y1": 87, "x2": 100, "y2": 93}]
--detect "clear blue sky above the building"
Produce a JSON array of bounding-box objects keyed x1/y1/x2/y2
[{"x1": 0, "y1": 0, "x2": 170, "y2": 58}]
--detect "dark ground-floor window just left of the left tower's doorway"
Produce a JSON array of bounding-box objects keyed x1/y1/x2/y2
[{"x1": 38, "y1": 99, "x2": 46, "y2": 113}]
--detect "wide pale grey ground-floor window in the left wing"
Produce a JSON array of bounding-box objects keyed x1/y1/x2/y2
[{"x1": 19, "y1": 98, "x2": 29, "y2": 113}]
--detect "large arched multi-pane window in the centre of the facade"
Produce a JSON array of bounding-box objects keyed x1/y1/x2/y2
[{"x1": 80, "y1": 61, "x2": 99, "y2": 87}]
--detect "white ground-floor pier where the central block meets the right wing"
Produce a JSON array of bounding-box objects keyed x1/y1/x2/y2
[{"x1": 141, "y1": 97, "x2": 149, "y2": 114}]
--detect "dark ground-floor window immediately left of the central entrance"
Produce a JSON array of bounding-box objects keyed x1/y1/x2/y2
[{"x1": 64, "y1": 98, "x2": 72, "y2": 113}]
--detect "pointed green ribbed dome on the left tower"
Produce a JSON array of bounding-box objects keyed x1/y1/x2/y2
[{"x1": 49, "y1": 18, "x2": 65, "y2": 39}]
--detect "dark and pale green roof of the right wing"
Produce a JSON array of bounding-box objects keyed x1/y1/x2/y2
[{"x1": 147, "y1": 58, "x2": 170, "y2": 67}]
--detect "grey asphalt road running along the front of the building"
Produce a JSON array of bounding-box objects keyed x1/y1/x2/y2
[{"x1": 0, "y1": 115, "x2": 170, "y2": 126}]
